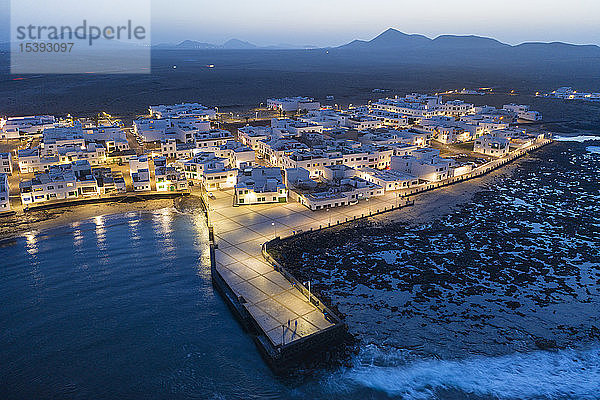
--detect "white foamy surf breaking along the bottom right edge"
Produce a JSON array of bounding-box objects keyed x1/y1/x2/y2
[{"x1": 338, "y1": 347, "x2": 600, "y2": 399}]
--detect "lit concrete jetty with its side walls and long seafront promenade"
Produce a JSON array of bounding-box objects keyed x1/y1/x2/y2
[{"x1": 203, "y1": 140, "x2": 551, "y2": 370}]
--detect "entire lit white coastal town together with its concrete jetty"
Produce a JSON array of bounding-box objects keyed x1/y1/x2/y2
[{"x1": 0, "y1": 94, "x2": 552, "y2": 370}]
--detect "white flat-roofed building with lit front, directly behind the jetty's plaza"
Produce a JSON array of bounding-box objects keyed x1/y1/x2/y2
[{"x1": 234, "y1": 167, "x2": 288, "y2": 205}]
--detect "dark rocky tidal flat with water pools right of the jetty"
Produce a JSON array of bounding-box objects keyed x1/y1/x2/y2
[{"x1": 273, "y1": 143, "x2": 600, "y2": 356}]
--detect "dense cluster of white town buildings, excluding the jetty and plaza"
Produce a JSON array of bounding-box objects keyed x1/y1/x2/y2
[{"x1": 0, "y1": 94, "x2": 548, "y2": 212}]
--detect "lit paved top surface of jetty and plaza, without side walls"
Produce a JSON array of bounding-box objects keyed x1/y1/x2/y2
[{"x1": 209, "y1": 190, "x2": 410, "y2": 346}]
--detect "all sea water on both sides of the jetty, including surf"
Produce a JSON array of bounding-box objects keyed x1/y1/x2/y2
[{"x1": 0, "y1": 139, "x2": 600, "y2": 399}]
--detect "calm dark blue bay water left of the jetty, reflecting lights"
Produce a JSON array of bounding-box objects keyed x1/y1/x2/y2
[{"x1": 0, "y1": 209, "x2": 290, "y2": 399}]
